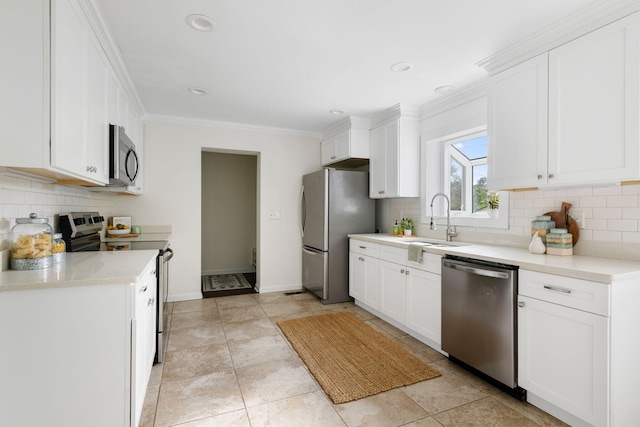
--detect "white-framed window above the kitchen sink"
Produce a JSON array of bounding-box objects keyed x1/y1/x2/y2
[{"x1": 422, "y1": 126, "x2": 509, "y2": 229}]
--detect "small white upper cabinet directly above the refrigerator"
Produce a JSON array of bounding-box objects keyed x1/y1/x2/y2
[{"x1": 321, "y1": 116, "x2": 371, "y2": 167}]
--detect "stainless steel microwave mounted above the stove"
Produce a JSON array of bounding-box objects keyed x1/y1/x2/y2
[{"x1": 109, "y1": 125, "x2": 140, "y2": 187}]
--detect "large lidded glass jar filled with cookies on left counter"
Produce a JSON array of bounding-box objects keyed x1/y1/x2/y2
[{"x1": 10, "y1": 213, "x2": 53, "y2": 270}]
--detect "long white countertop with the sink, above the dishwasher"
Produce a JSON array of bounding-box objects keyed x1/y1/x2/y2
[{"x1": 349, "y1": 234, "x2": 640, "y2": 283}]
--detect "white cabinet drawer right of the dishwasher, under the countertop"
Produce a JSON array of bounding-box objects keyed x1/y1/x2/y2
[{"x1": 518, "y1": 270, "x2": 610, "y2": 317}]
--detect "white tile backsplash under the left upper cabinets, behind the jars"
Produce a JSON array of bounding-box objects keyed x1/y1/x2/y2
[{"x1": 0, "y1": 175, "x2": 115, "y2": 270}]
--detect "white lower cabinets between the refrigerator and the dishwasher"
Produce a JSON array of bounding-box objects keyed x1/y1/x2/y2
[{"x1": 349, "y1": 239, "x2": 442, "y2": 349}]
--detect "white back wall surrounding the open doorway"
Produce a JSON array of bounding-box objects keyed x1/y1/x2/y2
[{"x1": 115, "y1": 120, "x2": 321, "y2": 301}]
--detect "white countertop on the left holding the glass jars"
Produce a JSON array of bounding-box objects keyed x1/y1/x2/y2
[{"x1": 0, "y1": 250, "x2": 158, "y2": 292}]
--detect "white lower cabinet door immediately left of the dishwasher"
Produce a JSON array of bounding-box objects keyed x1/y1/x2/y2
[{"x1": 406, "y1": 268, "x2": 442, "y2": 344}]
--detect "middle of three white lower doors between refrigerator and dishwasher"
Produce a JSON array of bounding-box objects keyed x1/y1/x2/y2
[{"x1": 380, "y1": 260, "x2": 407, "y2": 323}]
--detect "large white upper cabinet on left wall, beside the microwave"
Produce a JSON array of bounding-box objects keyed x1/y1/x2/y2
[{"x1": 0, "y1": 0, "x2": 141, "y2": 186}]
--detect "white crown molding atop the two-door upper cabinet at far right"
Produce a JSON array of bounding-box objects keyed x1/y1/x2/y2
[{"x1": 476, "y1": 0, "x2": 640, "y2": 75}]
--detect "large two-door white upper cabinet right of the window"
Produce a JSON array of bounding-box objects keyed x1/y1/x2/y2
[{"x1": 488, "y1": 13, "x2": 640, "y2": 189}]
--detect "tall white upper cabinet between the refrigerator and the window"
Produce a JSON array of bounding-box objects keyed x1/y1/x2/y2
[{"x1": 369, "y1": 105, "x2": 420, "y2": 199}]
